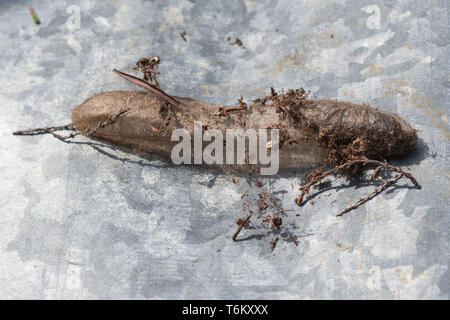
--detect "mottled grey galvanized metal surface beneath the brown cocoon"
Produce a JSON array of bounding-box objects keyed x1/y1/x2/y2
[{"x1": 0, "y1": 0, "x2": 450, "y2": 299}]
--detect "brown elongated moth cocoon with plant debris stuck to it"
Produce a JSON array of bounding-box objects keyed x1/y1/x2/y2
[{"x1": 72, "y1": 86, "x2": 417, "y2": 172}]
